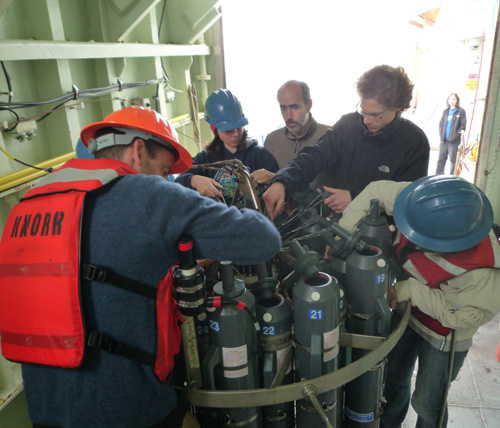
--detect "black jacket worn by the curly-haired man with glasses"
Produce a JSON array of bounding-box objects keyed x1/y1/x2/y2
[{"x1": 272, "y1": 113, "x2": 430, "y2": 199}]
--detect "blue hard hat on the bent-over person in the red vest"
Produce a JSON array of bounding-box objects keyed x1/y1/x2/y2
[{"x1": 394, "y1": 175, "x2": 493, "y2": 253}]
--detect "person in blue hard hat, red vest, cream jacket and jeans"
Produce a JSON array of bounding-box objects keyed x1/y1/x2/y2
[{"x1": 339, "y1": 176, "x2": 500, "y2": 428}]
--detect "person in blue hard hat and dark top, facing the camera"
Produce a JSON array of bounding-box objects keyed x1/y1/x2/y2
[{"x1": 176, "y1": 89, "x2": 279, "y2": 200}]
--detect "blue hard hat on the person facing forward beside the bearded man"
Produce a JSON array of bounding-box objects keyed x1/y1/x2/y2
[{"x1": 205, "y1": 89, "x2": 248, "y2": 131}]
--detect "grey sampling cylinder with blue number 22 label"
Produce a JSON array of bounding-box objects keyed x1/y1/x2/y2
[{"x1": 253, "y1": 278, "x2": 295, "y2": 428}]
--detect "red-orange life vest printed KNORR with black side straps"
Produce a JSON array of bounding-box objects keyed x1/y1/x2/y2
[{"x1": 0, "y1": 159, "x2": 180, "y2": 381}]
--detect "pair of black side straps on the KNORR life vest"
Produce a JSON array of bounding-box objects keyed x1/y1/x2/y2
[{"x1": 80, "y1": 263, "x2": 157, "y2": 367}]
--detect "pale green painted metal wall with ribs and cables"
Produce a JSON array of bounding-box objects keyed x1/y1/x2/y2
[{"x1": 0, "y1": 0, "x2": 224, "y2": 422}]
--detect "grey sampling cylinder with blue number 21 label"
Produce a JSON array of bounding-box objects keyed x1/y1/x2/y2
[{"x1": 293, "y1": 273, "x2": 341, "y2": 428}]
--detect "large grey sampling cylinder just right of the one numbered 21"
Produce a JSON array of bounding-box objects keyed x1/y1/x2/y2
[{"x1": 345, "y1": 246, "x2": 390, "y2": 428}]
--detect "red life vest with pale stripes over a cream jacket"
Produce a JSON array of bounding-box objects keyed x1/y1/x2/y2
[{"x1": 396, "y1": 230, "x2": 500, "y2": 336}]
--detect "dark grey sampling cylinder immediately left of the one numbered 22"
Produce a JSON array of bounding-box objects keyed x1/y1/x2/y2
[{"x1": 202, "y1": 262, "x2": 262, "y2": 428}]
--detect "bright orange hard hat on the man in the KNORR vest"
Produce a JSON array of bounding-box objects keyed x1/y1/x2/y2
[{"x1": 80, "y1": 106, "x2": 193, "y2": 174}]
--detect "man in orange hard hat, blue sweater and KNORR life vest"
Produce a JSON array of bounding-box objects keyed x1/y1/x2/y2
[{"x1": 0, "y1": 107, "x2": 281, "y2": 428}]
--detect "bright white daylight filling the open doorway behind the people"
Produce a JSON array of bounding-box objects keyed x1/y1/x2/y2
[{"x1": 222, "y1": 0, "x2": 496, "y2": 154}]
